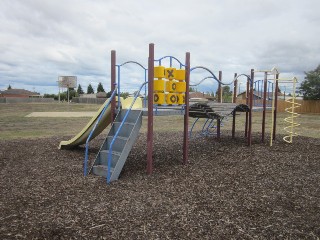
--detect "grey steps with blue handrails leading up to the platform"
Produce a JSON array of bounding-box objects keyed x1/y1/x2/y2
[{"x1": 91, "y1": 110, "x2": 142, "y2": 182}]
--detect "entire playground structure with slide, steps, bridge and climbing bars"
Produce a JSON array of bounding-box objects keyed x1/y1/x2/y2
[{"x1": 60, "y1": 44, "x2": 298, "y2": 183}]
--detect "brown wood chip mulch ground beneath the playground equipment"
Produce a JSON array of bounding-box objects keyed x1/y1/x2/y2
[{"x1": 0, "y1": 133, "x2": 320, "y2": 239}]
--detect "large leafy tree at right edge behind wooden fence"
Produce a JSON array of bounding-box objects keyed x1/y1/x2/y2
[{"x1": 300, "y1": 65, "x2": 320, "y2": 100}]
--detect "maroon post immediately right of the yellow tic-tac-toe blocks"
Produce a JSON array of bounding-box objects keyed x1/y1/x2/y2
[{"x1": 183, "y1": 52, "x2": 190, "y2": 164}]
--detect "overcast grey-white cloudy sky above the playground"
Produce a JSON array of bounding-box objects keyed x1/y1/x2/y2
[{"x1": 0, "y1": 0, "x2": 320, "y2": 94}]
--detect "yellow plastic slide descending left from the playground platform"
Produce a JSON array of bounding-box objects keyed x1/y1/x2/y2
[{"x1": 59, "y1": 97, "x2": 142, "y2": 149}]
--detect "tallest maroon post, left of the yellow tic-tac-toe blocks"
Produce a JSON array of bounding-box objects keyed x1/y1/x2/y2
[{"x1": 147, "y1": 43, "x2": 154, "y2": 174}]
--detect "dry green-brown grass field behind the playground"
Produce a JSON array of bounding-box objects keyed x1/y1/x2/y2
[{"x1": 0, "y1": 103, "x2": 320, "y2": 140}]
